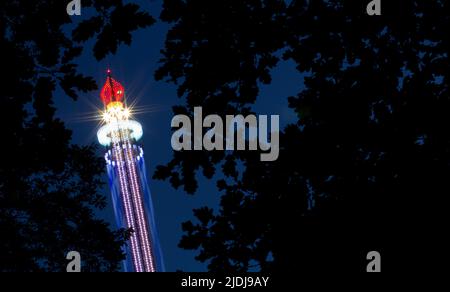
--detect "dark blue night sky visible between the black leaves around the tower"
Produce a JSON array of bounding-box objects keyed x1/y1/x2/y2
[{"x1": 56, "y1": 0, "x2": 303, "y2": 271}]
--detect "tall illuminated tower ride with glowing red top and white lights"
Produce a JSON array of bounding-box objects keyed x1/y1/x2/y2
[{"x1": 97, "y1": 70, "x2": 164, "y2": 272}]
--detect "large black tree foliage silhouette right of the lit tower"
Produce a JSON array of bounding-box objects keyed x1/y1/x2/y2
[{"x1": 154, "y1": 0, "x2": 450, "y2": 271}]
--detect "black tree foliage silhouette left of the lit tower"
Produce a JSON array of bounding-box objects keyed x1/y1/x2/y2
[{"x1": 0, "y1": 0, "x2": 154, "y2": 271}]
